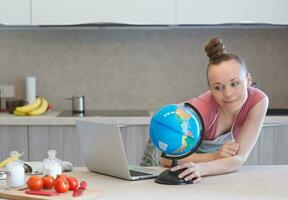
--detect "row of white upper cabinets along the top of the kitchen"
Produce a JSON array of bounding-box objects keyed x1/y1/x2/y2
[{"x1": 0, "y1": 0, "x2": 288, "y2": 26}]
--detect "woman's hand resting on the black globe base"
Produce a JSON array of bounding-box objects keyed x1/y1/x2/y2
[{"x1": 170, "y1": 162, "x2": 201, "y2": 183}]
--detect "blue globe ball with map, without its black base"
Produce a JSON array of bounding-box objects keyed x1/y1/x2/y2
[{"x1": 149, "y1": 104, "x2": 203, "y2": 156}]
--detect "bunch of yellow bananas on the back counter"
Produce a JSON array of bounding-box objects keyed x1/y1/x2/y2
[{"x1": 14, "y1": 97, "x2": 48, "y2": 116}]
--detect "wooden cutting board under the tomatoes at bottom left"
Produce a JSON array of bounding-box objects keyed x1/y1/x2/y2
[{"x1": 0, "y1": 189, "x2": 103, "y2": 200}]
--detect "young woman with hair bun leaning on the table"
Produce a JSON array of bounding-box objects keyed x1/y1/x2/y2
[{"x1": 160, "y1": 37, "x2": 268, "y2": 182}]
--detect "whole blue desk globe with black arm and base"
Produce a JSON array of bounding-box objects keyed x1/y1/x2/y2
[{"x1": 149, "y1": 103, "x2": 204, "y2": 184}]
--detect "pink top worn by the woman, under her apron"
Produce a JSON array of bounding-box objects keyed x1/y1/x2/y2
[{"x1": 186, "y1": 87, "x2": 266, "y2": 140}]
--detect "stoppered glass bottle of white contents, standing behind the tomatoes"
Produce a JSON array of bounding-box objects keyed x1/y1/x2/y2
[{"x1": 43, "y1": 150, "x2": 62, "y2": 178}]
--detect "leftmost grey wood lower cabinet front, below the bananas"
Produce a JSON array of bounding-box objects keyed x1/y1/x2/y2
[{"x1": 0, "y1": 125, "x2": 28, "y2": 161}]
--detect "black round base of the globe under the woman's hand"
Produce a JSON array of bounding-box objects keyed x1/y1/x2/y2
[{"x1": 155, "y1": 169, "x2": 193, "y2": 185}]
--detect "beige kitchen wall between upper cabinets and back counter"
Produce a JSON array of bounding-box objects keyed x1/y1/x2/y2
[{"x1": 0, "y1": 28, "x2": 288, "y2": 109}]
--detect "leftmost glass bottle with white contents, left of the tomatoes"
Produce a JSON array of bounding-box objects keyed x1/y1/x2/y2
[{"x1": 6, "y1": 151, "x2": 25, "y2": 188}]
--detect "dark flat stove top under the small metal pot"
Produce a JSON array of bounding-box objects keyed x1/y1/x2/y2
[{"x1": 58, "y1": 110, "x2": 150, "y2": 117}]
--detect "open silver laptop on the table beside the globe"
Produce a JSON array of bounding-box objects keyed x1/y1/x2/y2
[{"x1": 76, "y1": 120, "x2": 159, "y2": 180}]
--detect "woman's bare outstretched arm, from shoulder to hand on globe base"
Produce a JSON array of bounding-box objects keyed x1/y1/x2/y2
[{"x1": 172, "y1": 97, "x2": 268, "y2": 180}]
